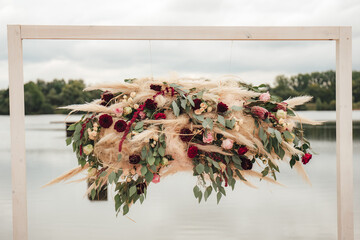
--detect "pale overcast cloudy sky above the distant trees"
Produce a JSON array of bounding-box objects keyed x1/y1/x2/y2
[{"x1": 0, "y1": 0, "x2": 360, "y2": 88}]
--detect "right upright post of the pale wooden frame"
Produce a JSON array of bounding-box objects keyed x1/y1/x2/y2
[{"x1": 336, "y1": 27, "x2": 354, "y2": 240}]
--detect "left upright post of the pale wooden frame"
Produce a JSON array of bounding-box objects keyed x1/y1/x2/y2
[{"x1": 8, "y1": 25, "x2": 28, "y2": 240}]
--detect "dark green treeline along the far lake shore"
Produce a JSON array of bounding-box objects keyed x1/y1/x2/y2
[{"x1": 0, "y1": 71, "x2": 360, "y2": 115}]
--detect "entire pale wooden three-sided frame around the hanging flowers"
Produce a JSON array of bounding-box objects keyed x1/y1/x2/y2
[{"x1": 8, "y1": 25, "x2": 354, "y2": 240}]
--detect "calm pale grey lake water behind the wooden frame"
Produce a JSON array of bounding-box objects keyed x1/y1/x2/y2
[{"x1": 0, "y1": 111, "x2": 360, "y2": 240}]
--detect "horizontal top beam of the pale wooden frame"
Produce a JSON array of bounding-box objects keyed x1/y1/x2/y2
[{"x1": 21, "y1": 25, "x2": 339, "y2": 40}]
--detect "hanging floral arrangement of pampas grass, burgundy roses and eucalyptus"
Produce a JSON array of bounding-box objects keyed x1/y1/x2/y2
[{"x1": 43, "y1": 78, "x2": 319, "y2": 215}]
